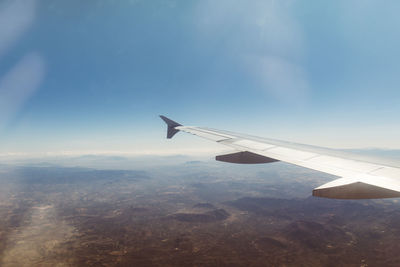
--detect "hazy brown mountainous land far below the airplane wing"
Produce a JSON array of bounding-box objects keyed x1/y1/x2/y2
[{"x1": 0, "y1": 163, "x2": 400, "y2": 266}]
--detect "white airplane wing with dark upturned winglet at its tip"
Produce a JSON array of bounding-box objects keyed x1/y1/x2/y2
[{"x1": 160, "y1": 115, "x2": 400, "y2": 199}]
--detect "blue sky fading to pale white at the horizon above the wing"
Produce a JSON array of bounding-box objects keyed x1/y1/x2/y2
[{"x1": 0, "y1": 0, "x2": 400, "y2": 155}]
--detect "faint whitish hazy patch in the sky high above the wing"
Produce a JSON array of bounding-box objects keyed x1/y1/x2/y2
[{"x1": 195, "y1": 0, "x2": 310, "y2": 102}]
